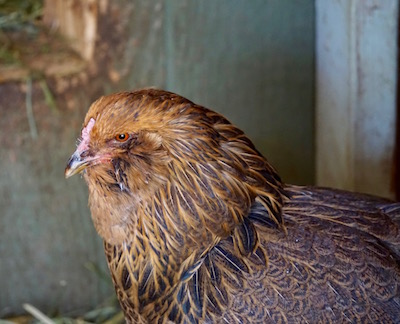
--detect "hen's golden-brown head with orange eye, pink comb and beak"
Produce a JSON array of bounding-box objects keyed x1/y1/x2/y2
[{"x1": 65, "y1": 89, "x2": 205, "y2": 192}]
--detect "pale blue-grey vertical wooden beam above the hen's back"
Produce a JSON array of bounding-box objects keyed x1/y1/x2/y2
[{"x1": 316, "y1": 0, "x2": 399, "y2": 197}]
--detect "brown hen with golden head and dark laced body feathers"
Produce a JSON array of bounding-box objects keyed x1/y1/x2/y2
[{"x1": 65, "y1": 89, "x2": 400, "y2": 323}]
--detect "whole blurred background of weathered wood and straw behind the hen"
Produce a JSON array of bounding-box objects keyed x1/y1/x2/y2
[{"x1": 0, "y1": 0, "x2": 400, "y2": 323}]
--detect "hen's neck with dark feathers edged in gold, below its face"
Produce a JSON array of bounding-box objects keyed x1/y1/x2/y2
[{"x1": 85, "y1": 141, "x2": 282, "y2": 313}]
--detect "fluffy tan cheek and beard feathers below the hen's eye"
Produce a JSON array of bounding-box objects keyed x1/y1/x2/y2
[{"x1": 85, "y1": 138, "x2": 170, "y2": 244}]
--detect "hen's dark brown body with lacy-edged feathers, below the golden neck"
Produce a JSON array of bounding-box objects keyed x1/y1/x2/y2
[{"x1": 105, "y1": 186, "x2": 400, "y2": 323}]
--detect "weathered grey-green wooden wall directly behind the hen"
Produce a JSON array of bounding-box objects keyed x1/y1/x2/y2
[{"x1": 0, "y1": 0, "x2": 314, "y2": 317}]
